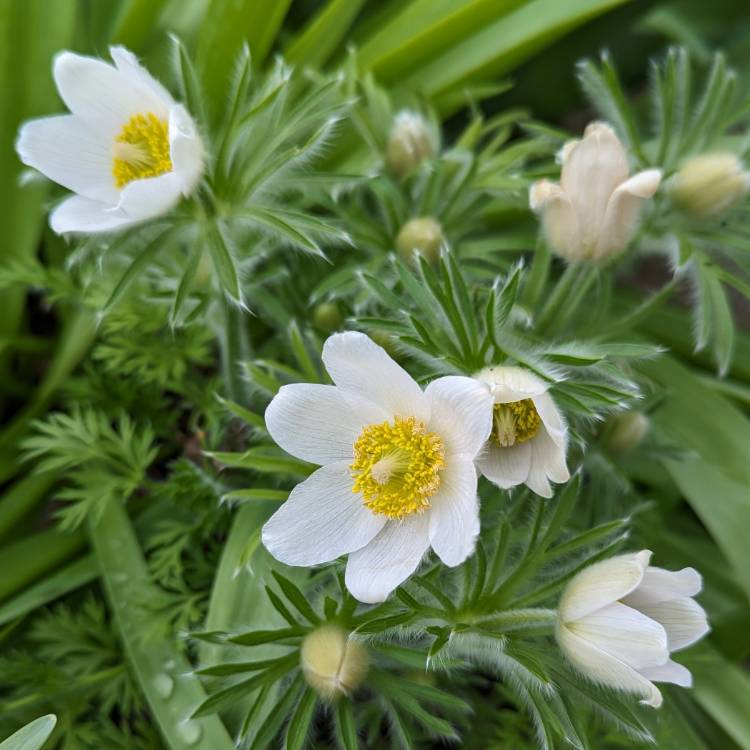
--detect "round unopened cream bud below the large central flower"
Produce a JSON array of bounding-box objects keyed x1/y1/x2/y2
[{"x1": 300, "y1": 625, "x2": 367, "y2": 700}]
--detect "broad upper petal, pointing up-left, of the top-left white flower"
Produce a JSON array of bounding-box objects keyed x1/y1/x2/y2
[{"x1": 54, "y1": 52, "x2": 169, "y2": 138}]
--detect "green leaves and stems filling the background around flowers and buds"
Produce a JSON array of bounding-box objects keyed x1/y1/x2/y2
[{"x1": 0, "y1": 0, "x2": 750, "y2": 750}]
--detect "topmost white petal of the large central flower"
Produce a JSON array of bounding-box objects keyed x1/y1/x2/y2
[{"x1": 323, "y1": 331, "x2": 430, "y2": 423}]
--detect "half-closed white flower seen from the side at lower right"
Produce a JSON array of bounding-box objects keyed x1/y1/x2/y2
[{"x1": 557, "y1": 550, "x2": 709, "y2": 708}]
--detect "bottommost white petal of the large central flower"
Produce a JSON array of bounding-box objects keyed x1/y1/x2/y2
[{"x1": 346, "y1": 511, "x2": 429, "y2": 604}]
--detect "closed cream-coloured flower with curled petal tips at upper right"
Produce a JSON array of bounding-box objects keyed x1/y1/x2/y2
[{"x1": 529, "y1": 122, "x2": 661, "y2": 261}]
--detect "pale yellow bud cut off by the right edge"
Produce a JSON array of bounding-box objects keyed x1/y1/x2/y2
[{"x1": 669, "y1": 152, "x2": 750, "y2": 219}]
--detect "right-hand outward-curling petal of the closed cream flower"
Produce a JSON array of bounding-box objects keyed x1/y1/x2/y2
[{"x1": 596, "y1": 169, "x2": 661, "y2": 258}]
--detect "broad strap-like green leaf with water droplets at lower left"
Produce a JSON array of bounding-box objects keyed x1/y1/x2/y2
[{"x1": 89, "y1": 502, "x2": 235, "y2": 750}]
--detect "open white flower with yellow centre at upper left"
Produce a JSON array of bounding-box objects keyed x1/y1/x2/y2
[{"x1": 16, "y1": 47, "x2": 203, "y2": 234}]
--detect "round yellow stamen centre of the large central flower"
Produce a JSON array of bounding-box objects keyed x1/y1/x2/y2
[{"x1": 350, "y1": 417, "x2": 445, "y2": 519}]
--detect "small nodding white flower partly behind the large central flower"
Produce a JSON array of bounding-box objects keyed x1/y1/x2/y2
[{"x1": 476, "y1": 366, "x2": 570, "y2": 497}]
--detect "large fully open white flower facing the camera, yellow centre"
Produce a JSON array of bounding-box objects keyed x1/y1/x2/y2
[{"x1": 263, "y1": 332, "x2": 492, "y2": 602}]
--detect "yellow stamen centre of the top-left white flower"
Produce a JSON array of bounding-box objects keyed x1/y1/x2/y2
[{"x1": 112, "y1": 112, "x2": 172, "y2": 188}]
